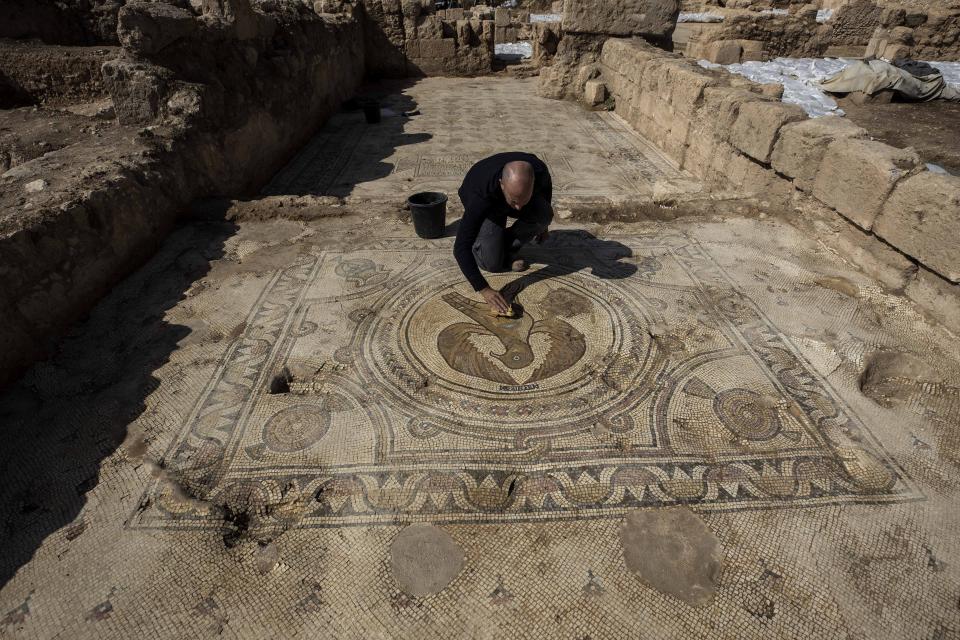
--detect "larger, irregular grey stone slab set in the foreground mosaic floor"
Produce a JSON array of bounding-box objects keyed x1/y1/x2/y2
[{"x1": 620, "y1": 507, "x2": 723, "y2": 607}]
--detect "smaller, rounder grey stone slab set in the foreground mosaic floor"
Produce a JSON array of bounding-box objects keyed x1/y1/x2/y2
[{"x1": 390, "y1": 523, "x2": 464, "y2": 596}]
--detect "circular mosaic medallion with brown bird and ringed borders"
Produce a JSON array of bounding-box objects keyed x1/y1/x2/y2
[{"x1": 358, "y1": 268, "x2": 661, "y2": 437}]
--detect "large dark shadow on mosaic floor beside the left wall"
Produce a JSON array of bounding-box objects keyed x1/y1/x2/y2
[{"x1": 0, "y1": 209, "x2": 236, "y2": 592}]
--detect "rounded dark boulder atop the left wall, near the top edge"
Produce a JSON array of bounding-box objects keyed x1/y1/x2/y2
[{"x1": 117, "y1": 2, "x2": 197, "y2": 55}]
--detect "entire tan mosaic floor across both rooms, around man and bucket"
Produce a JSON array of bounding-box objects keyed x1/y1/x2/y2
[{"x1": 0, "y1": 80, "x2": 960, "y2": 639}]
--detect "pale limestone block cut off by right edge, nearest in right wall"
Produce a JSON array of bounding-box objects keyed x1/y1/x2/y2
[{"x1": 873, "y1": 171, "x2": 960, "y2": 283}]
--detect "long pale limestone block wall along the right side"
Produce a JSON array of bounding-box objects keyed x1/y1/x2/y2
[{"x1": 600, "y1": 38, "x2": 960, "y2": 331}]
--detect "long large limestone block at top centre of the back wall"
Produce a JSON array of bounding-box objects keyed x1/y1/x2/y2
[{"x1": 563, "y1": 0, "x2": 680, "y2": 36}]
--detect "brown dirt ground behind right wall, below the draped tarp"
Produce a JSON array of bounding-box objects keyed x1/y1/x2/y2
[{"x1": 843, "y1": 100, "x2": 960, "y2": 175}]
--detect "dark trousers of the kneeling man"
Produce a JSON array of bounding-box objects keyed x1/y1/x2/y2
[{"x1": 473, "y1": 195, "x2": 553, "y2": 273}]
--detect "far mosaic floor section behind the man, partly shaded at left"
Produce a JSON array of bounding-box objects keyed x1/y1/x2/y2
[{"x1": 265, "y1": 78, "x2": 692, "y2": 202}]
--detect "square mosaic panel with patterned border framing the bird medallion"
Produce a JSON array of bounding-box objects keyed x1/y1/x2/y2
[{"x1": 133, "y1": 231, "x2": 920, "y2": 528}]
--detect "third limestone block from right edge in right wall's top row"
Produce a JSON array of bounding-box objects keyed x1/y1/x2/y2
[{"x1": 770, "y1": 117, "x2": 867, "y2": 192}]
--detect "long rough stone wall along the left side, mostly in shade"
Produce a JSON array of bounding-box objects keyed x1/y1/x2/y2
[{"x1": 0, "y1": 0, "x2": 364, "y2": 384}]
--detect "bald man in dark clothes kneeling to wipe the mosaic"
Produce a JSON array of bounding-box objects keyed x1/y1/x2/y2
[{"x1": 453, "y1": 151, "x2": 553, "y2": 313}]
